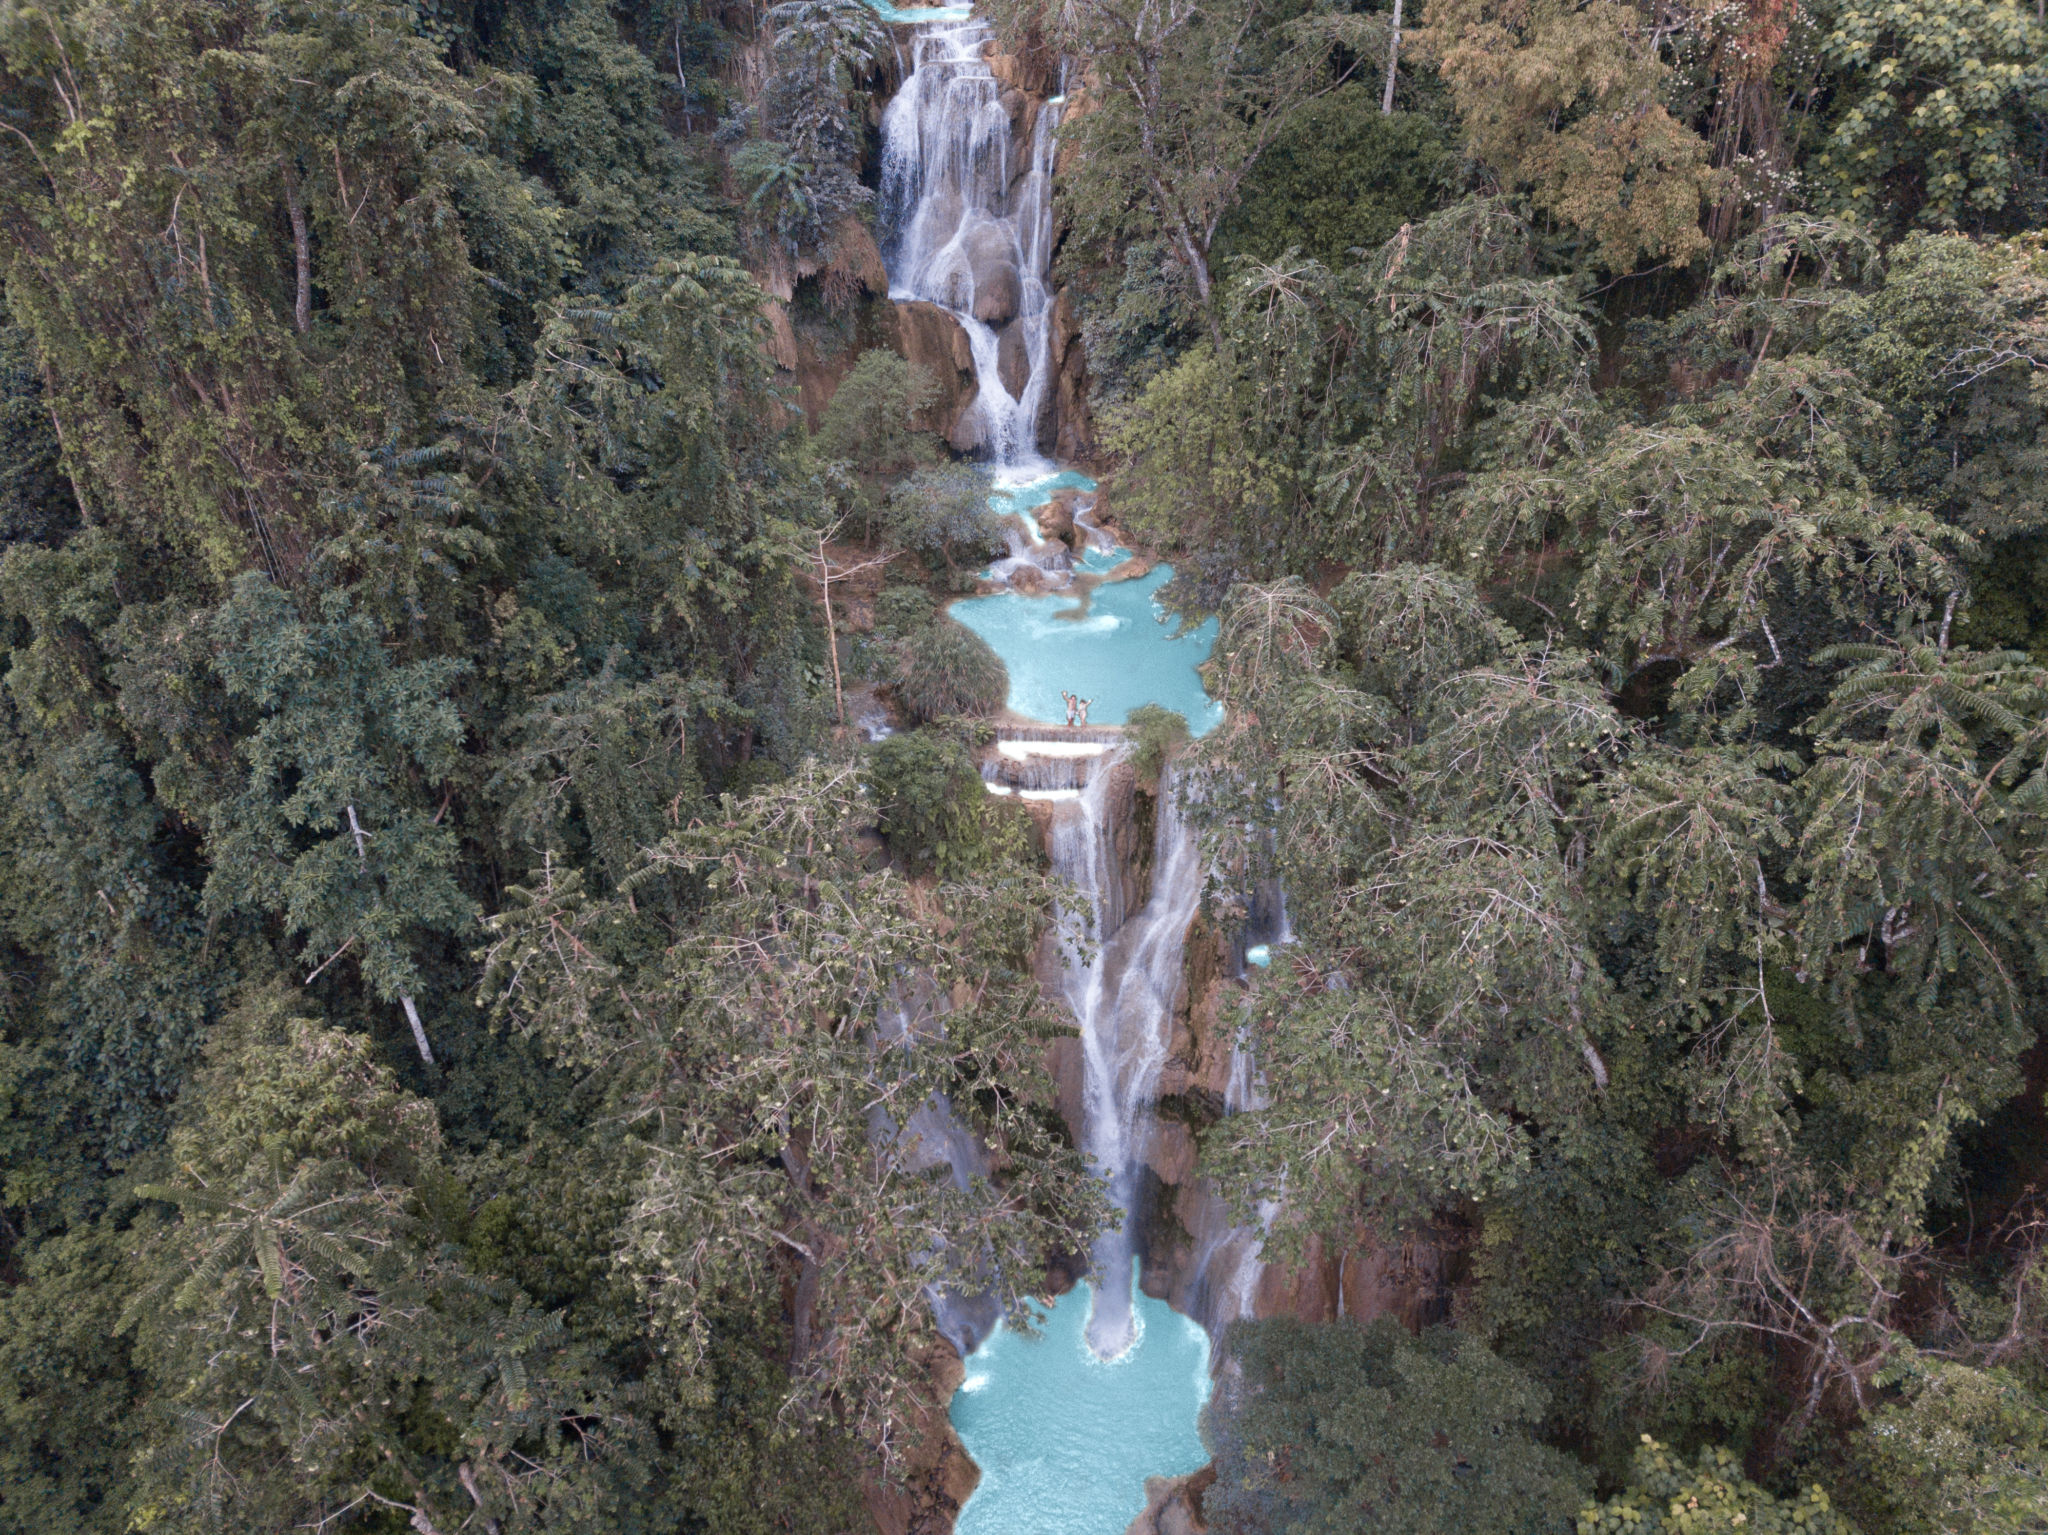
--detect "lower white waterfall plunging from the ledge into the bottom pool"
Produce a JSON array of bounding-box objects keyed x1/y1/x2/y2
[{"x1": 1051, "y1": 772, "x2": 1202, "y2": 1359}]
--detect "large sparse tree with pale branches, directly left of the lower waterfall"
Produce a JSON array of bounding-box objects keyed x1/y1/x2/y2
[{"x1": 479, "y1": 761, "x2": 1102, "y2": 1455}]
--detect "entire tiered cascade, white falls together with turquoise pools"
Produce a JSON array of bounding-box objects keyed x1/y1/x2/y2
[{"x1": 877, "y1": 10, "x2": 1245, "y2": 1535}]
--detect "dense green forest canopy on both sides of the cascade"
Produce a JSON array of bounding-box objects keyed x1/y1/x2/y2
[{"x1": 0, "y1": 0, "x2": 2048, "y2": 1535}]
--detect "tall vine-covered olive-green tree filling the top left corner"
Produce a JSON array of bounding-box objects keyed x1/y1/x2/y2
[{"x1": 0, "y1": 0, "x2": 559, "y2": 583}]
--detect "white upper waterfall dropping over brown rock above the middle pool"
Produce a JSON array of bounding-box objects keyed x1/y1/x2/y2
[{"x1": 881, "y1": 18, "x2": 1059, "y2": 471}]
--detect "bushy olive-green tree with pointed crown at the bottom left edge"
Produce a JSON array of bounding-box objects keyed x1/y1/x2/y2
[{"x1": 119, "y1": 995, "x2": 629, "y2": 1529}]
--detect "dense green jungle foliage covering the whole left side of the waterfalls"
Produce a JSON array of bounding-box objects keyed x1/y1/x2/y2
[{"x1": 0, "y1": 0, "x2": 1100, "y2": 1535}]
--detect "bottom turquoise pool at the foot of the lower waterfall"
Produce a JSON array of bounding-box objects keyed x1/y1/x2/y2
[{"x1": 950, "y1": 1283, "x2": 1208, "y2": 1535}]
